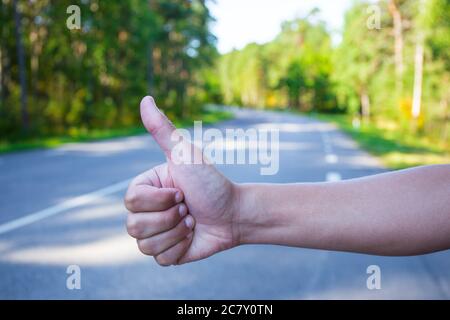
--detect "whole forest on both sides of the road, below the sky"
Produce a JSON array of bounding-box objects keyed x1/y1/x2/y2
[{"x1": 0, "y1": 0, "x2": 450, "y2": 155}]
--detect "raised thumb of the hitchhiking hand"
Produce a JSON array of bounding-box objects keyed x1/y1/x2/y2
[{"x1": 141, "y1": 96, "x2": 176, "y2": 156}]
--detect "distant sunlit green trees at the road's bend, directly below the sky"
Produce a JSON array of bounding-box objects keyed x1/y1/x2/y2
[{"x1": 217, "y1": 12, "x2": 336, "y2": 111}]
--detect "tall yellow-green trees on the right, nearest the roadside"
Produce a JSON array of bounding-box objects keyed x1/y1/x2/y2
[{"x1": 333, "y1": 0, "x2": 450, "y2": 145}]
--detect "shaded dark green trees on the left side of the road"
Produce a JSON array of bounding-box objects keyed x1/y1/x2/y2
[{"x1": 0, "y1": 0, "x2": 217, "y2": 140}]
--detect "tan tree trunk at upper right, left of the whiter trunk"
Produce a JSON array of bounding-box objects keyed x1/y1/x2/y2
[{"x1": 388, "y1": 0, "x2": 404, "y2": 94}]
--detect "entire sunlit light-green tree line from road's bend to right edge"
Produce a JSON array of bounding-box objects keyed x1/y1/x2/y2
[{"x1": 217, "y1": 0, "x2": 450, "y2": 152}]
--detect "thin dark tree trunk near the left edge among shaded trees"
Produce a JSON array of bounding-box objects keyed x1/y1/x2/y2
[{"x1": 13, "y1": 0, "x2": 29, "y2": 132}]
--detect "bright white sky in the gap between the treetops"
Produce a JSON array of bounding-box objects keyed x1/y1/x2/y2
[{"x1": 209, "y1": 0, "x2": 352, "y2": 53}]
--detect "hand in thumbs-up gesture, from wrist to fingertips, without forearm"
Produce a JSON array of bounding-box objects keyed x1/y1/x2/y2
[{"x1": 125, "y1": 96, "x2": 239, "y2": 266}]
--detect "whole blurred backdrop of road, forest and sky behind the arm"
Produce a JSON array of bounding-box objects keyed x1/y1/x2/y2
[{"x1": 0, "y1": 0, "x2": 450, "y2": 298}]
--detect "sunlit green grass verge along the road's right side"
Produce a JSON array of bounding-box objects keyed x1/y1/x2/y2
[{"x1": 313, "y1": 114, "x2": 450, "y2": 169}]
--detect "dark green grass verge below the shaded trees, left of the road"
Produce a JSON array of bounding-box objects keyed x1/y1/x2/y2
[{"x1": 0, "y1": 110, "x2": 233, "y2": 154}]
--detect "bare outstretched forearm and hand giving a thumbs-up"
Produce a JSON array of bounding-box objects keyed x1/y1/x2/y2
[{"x1": 125, "y1": 97, "x2": 450, "y2": 266}]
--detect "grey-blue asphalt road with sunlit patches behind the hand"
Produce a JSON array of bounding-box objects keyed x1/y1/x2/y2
[{"x1": 0, "y1": 111, "x2": 450, "y2": 299}]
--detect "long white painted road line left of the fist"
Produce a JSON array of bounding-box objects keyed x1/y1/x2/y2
[{"x1": 0, "y1": 179, "x2": 130, "y2": 234}]
